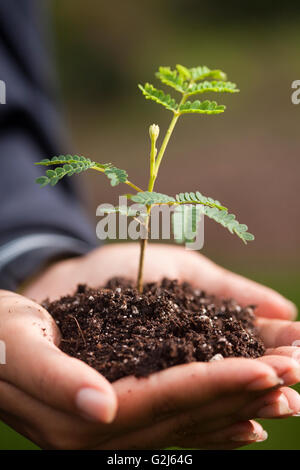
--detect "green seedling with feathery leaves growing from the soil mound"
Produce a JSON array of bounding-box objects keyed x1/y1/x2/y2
[{"x1": 36, "y1": 65, "x2": 254, "y2": 292}]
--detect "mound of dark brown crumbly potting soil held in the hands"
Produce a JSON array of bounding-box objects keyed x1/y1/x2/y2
[{"x1": 43, "y1": 278, "x2": 265, "y2": 382}]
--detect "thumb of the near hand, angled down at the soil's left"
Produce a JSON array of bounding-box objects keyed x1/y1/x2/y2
[{"x1": 0, "y1": 336, "x2": 117, "y2": 423}]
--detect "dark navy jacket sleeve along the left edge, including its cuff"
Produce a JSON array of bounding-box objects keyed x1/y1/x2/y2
[{"x1": 0, "y1": 0, "x2": 96, "y2": 289}]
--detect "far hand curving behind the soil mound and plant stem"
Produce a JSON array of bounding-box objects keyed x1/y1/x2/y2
[{"x1": 24, "y1": 243, "x2": 297, "y2": 320}]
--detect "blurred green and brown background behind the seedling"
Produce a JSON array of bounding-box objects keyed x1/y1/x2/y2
[{"x1": 0, "y1": 0, "x2": 300, "y2": 449}]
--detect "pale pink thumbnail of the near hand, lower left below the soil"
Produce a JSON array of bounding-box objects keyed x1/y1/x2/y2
[{"x1": 75, "y1": 388, "x2": 116, "y2": 423}]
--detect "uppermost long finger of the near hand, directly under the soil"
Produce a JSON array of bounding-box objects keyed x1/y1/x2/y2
[{"x1": 113, "y1": 358, "x2": 282, "y2": 432}]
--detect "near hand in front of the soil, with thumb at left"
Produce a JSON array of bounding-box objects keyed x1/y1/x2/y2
[{"x1": 0, "y1": 291, "x2": 300, "y2": 449}]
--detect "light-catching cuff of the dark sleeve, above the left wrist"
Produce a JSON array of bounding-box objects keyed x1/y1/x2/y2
[{"x1": 0, "y1": 233, "x2": 94, "y2": 291}]
